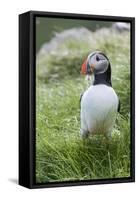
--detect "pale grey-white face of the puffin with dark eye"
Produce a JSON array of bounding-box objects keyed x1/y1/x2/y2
[{"x1": 87, "y1": 52, "x2": 109, "y2": 74}]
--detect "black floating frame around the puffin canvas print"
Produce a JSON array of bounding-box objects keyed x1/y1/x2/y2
[{"x1": 19, "y1": 11, "x2": 135, "y2": 188}]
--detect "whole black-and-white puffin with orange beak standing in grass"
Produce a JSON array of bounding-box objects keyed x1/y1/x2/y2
[{"x1": 80, "y1": 51, "x2": 120, "y2": 138}]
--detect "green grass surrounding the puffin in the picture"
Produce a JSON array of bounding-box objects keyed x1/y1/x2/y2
[{"x1": 36, "y1": 28, "x2": 130, "y2": 183}]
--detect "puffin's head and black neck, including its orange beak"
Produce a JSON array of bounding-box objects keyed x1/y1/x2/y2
[{"x1": 81, "y1": 51, "x2": 112, "y2": 86}]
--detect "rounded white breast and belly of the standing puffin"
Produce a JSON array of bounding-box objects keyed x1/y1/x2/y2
[{"x1": 81, "y1": 84, "x2": 118, "y2": 133}]
